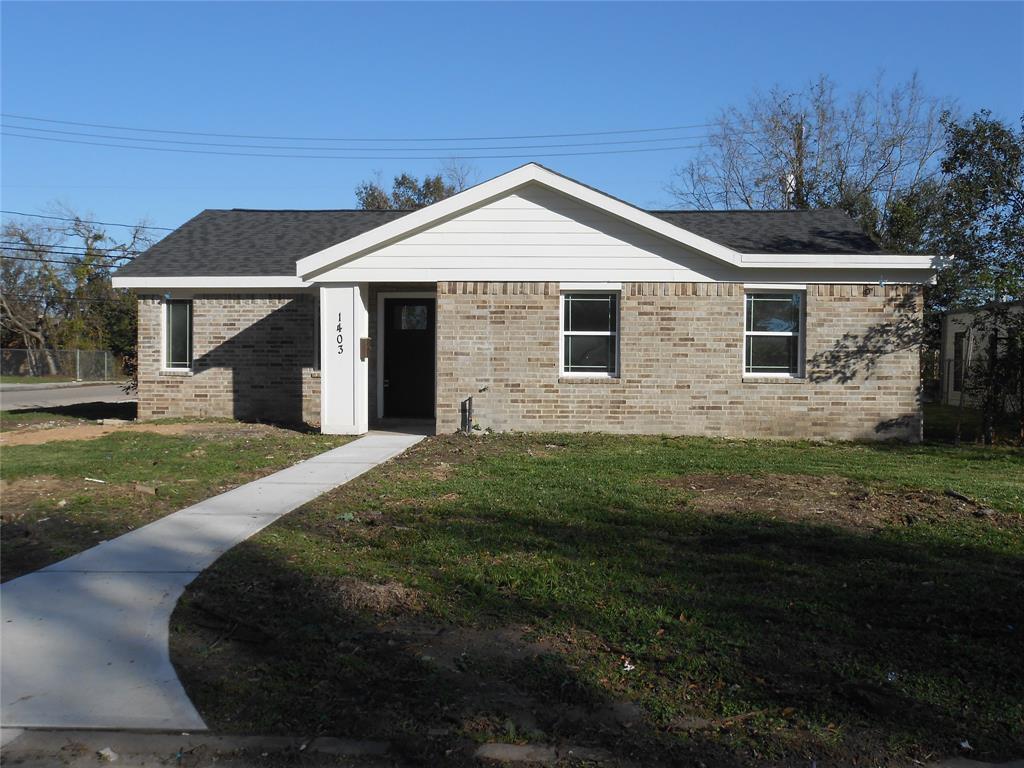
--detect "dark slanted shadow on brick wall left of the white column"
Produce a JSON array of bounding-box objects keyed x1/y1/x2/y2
[{"x1": 194, "y1": 297, "x2": 315, "y2": 427}]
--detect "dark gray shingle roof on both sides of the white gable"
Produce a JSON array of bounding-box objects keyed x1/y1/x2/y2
[{"x1": 118, "y1": 208, "x2": 881, "y2": 278}]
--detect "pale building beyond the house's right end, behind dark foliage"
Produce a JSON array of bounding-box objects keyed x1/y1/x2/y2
[{"x1": 939, "y1": 301, "x2": 1024, "y2": 412}]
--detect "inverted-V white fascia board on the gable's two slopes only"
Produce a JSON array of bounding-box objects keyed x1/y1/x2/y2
[{"x1": 296, "y1": 163, "x2": 740, "y2": 279}]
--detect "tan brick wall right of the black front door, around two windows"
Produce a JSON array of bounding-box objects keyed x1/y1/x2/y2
[{"x1": 437, "y1": 283, "x2": 922, "y2": 440}]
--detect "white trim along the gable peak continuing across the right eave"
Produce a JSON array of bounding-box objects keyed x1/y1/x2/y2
[{"x1": 296, "y1": 163, "x2": 933, "y2": 281}]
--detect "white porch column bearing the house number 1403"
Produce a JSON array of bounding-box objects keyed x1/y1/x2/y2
[{"x1": 319, "y1": 283, "x2": 370, "y2": 434}]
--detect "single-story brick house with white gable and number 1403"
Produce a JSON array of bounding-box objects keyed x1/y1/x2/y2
[{"x1": 114, "y1": 163, "x2": 933, "y2": 440}]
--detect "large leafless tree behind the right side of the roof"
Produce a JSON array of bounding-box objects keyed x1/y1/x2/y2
[{"x1": 669, "y1": 76, "x2": 951, "y2": 243}]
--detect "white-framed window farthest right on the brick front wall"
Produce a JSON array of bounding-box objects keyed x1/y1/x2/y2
[{"x1": 743, "y1": 293, "x2": 804, "y2": 377}]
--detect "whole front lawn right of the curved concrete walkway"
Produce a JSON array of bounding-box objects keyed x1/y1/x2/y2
[{"x1": 172, "y1": 435, "x2": 1024, "y2": 767}]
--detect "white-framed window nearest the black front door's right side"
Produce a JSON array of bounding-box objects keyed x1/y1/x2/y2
[{"x1": 562, "y1": 293, "x2": 618, "y2": 376}]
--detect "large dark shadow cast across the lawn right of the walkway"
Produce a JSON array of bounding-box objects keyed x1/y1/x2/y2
[{"x1": 172, "y1": 502, "x2": 1024, "y2": 766}]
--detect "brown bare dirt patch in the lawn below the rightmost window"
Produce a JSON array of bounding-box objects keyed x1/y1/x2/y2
[{"x1": 663, "y1": 475, "x2": 1017, "y2": 530}]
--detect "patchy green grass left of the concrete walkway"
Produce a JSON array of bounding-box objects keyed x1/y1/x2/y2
[{"x1": 0, "y1": 423, "x2": 346, "y2": 580}]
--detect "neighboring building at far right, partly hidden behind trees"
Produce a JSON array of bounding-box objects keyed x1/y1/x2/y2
[{"x1": 939, "y1": 301, "x2": 1024, "y2": 413}]
